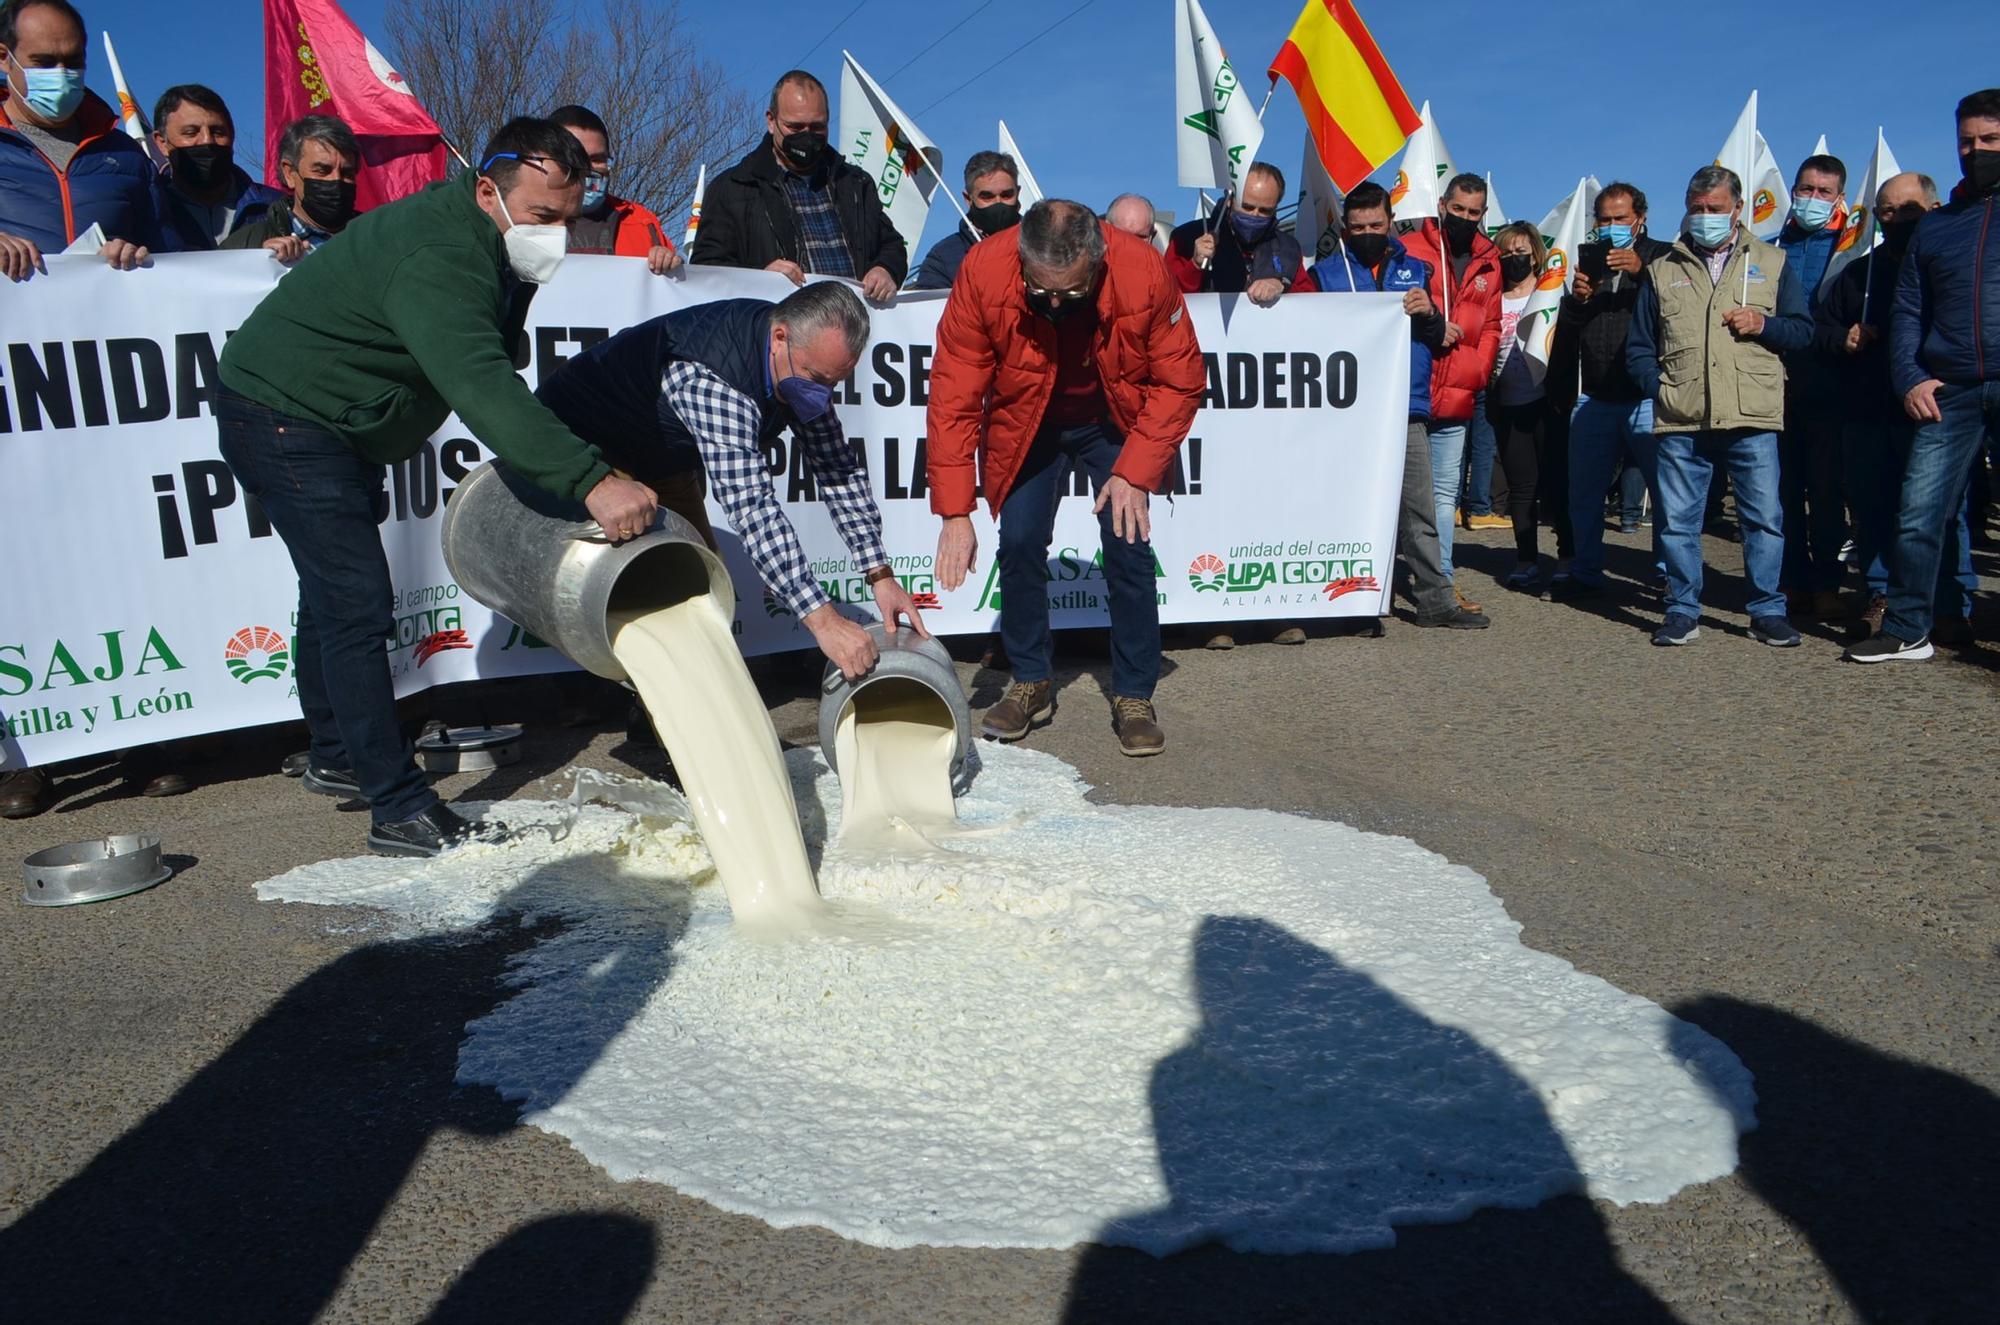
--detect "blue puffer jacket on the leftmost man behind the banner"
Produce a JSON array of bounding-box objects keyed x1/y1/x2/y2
[{"x1": 0, "y1": 92, "x2": 160, "y2": 252}]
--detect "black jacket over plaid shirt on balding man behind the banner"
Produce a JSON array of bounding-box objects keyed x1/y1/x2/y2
[{"x1": 688, "y1": 134, "x2": 910, "y2": 286}]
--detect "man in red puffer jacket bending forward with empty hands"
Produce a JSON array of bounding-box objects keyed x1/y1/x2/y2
[{"x1": 926, "y1": 198, "x2": 1208, "y2": 755}]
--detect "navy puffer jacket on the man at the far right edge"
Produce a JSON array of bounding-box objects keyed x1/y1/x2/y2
[{"x1": 1888, "y1": 192, "x2": 2000, "y2": 394}]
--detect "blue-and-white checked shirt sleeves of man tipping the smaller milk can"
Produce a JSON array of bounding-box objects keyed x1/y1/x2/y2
[{"x1": 660, "y1": 360, "x2": 888, "y2": 618}]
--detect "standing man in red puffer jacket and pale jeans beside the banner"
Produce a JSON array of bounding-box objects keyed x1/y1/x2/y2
[{"x1": 1402, "y1": 174, "x2": 1502, "y2": 612}]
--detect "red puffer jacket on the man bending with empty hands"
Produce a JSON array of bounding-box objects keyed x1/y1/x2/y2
[{"x1": 926, "y1": 226, "x2": 1208, "y2": 516}]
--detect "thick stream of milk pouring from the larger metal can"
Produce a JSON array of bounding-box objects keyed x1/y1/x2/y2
[{"x1": 608, "y1": 594, "x2": 822, "y2": 929}]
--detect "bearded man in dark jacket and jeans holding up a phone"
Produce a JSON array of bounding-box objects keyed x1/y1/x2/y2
[{"x1": 1548, "y1": 182, "x2": 1672, "y2": 598}]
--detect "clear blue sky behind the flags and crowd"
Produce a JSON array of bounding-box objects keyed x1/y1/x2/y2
[{"x1": 82, "y1": 0, "x2": 2000, "y2": 255}]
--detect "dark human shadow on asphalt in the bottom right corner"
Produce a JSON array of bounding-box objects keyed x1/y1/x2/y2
[{"x1": 1674, "y1": 997, "x2": 2000, "y2": 1325}]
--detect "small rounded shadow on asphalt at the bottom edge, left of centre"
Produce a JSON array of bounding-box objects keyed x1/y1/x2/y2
[{"x1": 424, "y1": 1213, "x2": 658, "y2": 1325}]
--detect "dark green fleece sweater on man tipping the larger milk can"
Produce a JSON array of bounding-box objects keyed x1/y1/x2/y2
[{"x1": 220, "y1": 170, "x2": 610, "y2": 500}]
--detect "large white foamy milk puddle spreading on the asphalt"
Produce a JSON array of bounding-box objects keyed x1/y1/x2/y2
[{"x1": 258, "y1": 748, "x2": 1754, "y2": 1253}]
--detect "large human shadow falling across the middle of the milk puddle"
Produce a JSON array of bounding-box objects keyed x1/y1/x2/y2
[{"x1": 1064, "y1": 917, "x2": 1674, "y2": 1325}]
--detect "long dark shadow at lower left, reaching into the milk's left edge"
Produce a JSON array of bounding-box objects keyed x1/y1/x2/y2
[{"x1": 0, "y1": 871, "x2": 686, "y2": 1325}]
